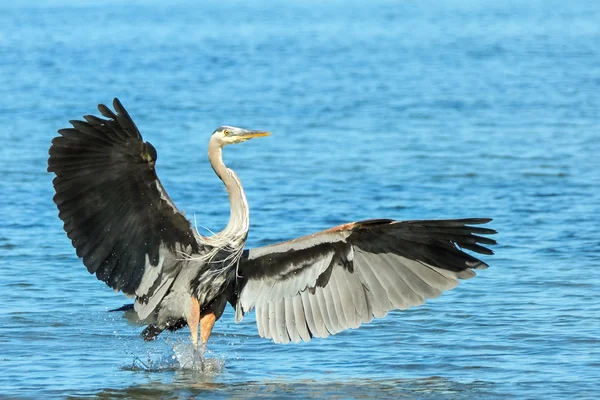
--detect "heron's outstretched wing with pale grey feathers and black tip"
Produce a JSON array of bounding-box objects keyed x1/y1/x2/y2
[{"x1": 236, "y1": 219, "x2": 496, "y2": 343}]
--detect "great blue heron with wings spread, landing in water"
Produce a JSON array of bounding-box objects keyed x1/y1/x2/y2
[{"x1": 48, "y1": 99, "x2": 495, "y2": 346}]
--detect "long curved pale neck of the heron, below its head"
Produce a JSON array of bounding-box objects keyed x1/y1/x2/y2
[{"x1": 208, "y1": 139, "x2": 250, "y2": 240}]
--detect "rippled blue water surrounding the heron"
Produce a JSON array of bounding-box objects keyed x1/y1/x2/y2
[{"x1": 0, "y1": 0, "x2": 600, "y2": 398}]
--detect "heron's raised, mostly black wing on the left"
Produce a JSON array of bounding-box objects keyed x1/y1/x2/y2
[{"x1": 48, "y1": 99, "x2": 200, "y2": 316}]
